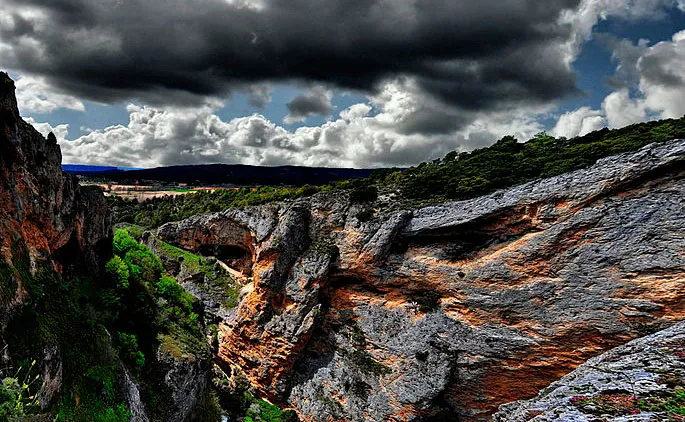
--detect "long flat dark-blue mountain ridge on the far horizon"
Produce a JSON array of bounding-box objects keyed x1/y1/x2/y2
[{"x1": 63, "y1": 164, "x2": 374, "y2": 186}]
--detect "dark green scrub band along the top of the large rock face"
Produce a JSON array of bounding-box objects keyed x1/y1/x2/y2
[{"x1": 110, "y1": 117, "x2": 685, "y2": 227}]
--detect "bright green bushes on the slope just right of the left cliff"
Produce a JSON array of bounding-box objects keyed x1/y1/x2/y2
[{"x1": 101, "y1": 230, "x2": 209, "y2": 362}]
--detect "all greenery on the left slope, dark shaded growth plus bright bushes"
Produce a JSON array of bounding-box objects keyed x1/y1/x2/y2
[{"x1": 0, "y1": 230, "x2": 210, "y2": 422}]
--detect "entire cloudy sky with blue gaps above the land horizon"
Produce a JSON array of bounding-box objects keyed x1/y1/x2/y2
[{"x1": 0, "y1": 0, "x2": 685, "y2": 168}]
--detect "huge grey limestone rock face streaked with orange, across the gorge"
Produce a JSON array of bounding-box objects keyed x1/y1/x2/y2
[{"x1": 158, "y1": 140, "x2": 685, "y2": 421}]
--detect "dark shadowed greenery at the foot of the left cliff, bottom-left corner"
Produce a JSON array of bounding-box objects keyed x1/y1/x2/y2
[{"x1": 0, "y1": 241, "x2": 135, "y2": 422}]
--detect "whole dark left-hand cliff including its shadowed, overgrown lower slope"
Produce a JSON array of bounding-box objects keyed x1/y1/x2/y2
[{"x1": 0, "y1": 72, "x2": 211, "y2": 422}]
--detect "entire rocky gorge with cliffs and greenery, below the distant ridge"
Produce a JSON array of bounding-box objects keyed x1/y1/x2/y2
[{"x1": 0, "y1": 74, "x2": 685, "y2": 422}]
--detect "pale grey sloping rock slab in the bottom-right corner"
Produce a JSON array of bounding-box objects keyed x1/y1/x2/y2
[{"x1": 495, "y1": 322, "x2": 685, "y2": 422}]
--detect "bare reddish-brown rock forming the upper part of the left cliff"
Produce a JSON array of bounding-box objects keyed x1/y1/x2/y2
[{"x1": 0, "y1": 72, "x2": 111, "y2": 308}]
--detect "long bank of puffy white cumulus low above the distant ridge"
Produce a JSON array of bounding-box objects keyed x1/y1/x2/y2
[{"x1": 56, "y1": 81, "x2": 543, "y2": 167}]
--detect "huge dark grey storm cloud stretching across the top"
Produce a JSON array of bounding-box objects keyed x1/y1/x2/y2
[{"x1": 0, "y1": 0, "x2": 580, "y2": 109}]
